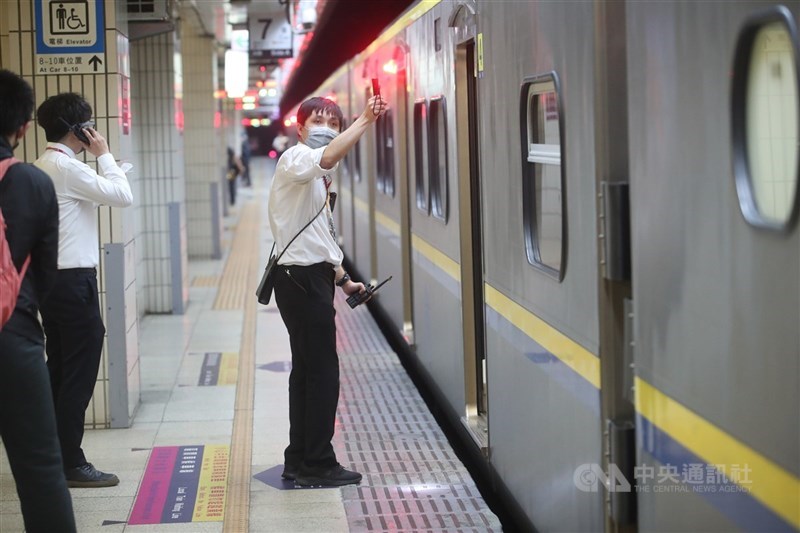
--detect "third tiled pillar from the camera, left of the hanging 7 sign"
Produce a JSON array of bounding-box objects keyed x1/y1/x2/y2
[{"x1": 181, "y1": 5, "x2": 224, "y2": 258}]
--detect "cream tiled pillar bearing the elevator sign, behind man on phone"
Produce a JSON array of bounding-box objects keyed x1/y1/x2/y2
[{"x1": 0, "y1": 0, "x2": 140, "y2": 427}]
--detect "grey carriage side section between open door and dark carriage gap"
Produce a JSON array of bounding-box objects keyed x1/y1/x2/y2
[{"x1": 478, "y1": 2, "x2": 604, "y2": 531}]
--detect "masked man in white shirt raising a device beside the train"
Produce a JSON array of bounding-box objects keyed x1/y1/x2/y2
[{"x1": 268, "y1": 92, "x2": 387, "y2": 486}]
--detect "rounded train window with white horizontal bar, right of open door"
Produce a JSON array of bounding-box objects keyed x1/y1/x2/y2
[{"x1": 520, "y1": 72, "x2": 565, "y2": 281}]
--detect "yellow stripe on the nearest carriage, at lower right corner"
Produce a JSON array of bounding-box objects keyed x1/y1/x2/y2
[{"x1": 635, "y1": 377, "x2": 800, "y2": 529}]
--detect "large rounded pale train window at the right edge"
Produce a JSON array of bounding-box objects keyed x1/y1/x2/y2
[{"x1": 731, "y1": 6, "x2": 800, "y2": 232}]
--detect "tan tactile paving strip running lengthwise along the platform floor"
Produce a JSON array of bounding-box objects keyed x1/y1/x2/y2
[{"x1": 219, "y1": 201, "x2": 261, "y2": 533}]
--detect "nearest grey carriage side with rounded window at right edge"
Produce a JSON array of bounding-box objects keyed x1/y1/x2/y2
[{"x1": 627, "y1": 2, "x2": 800, "y2": 531}]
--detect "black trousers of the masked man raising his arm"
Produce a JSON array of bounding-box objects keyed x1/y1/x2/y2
[{"x1": 275, "y1": 263, "x2": 339, "y2": 467}]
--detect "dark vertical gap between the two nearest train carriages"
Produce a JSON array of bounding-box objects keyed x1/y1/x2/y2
[{"x1": 594, "y1": 2, "x2": 636, "y2": 532}]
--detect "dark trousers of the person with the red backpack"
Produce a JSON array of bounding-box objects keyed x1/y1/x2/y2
[{"x1": 0, "y1": 331, "x2": 75, "y2": 532}]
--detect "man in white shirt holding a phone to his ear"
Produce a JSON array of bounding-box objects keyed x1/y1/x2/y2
[{"x1": 34, "y1": 93, "x2": 133, "y2": 488}]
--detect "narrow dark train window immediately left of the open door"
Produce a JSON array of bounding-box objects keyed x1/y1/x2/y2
[{"x1": 428, "y1": 96, "x2": 447, "y2": 222}]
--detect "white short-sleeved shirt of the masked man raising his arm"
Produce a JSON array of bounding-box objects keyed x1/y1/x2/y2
[{"x1": 269, "y1": 143, "x2": 344, "y2": 267}]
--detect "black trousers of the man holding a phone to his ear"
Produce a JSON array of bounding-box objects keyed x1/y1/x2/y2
[{"x1": 41, "y1": 268, "x2": 106, "y2": 469}]
